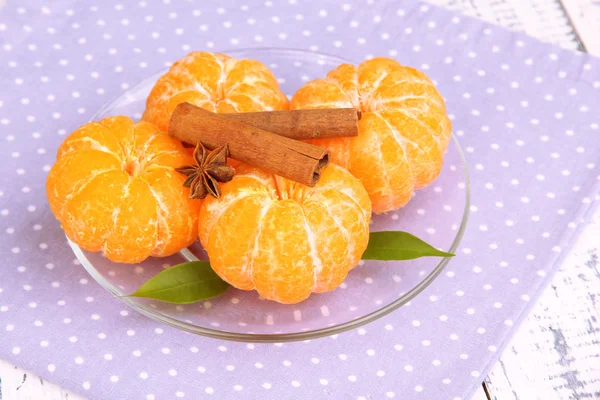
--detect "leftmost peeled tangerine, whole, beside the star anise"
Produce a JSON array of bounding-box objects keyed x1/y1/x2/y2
[{"x1": 46, "y1": 116, "x2": 201, "y2": 263}]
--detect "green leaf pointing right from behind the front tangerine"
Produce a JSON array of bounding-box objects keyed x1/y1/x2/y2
[{"x1": 362, "y1": 231, "x2": 454, "y2": 261}]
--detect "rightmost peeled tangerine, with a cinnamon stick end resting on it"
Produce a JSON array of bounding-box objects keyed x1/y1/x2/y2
[{"x1": 291, "y1": 58, "x2": 451, "y2": 213}]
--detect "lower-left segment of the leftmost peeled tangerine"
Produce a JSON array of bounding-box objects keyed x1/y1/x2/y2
[{"x1": 61, "y1": 169, "x2": 129, "y2": 251}]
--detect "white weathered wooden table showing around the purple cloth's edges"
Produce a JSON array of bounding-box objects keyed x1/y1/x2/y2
[{"x1": 0, "y1": 0, "x2": 600, "y2": 400}]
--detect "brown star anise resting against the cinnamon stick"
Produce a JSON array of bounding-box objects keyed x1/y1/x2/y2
[{"x1": 175, "y1": 142, "x2": 235, "y2": 199}]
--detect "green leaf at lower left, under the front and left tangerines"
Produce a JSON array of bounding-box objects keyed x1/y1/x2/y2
[{"x1": 129, "y1": 261, "x2": 229, "y2": 304}]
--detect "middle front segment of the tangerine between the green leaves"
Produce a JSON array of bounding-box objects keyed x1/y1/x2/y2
[{"x1": 252, "y1": 200, "x2": 314, "y2": 304}]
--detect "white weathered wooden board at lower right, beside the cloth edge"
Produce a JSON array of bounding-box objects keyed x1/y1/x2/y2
[{"x1": 486, "y1": 211, "x2": 600, "y2": 400}]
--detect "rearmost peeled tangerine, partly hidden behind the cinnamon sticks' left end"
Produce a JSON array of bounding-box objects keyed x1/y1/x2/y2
[{"x1": 142, "y1": 52, "x2": 288, "y2": 131}]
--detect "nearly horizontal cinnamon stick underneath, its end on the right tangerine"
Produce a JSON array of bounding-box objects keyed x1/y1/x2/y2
[{"x1": 223, "y1": 108, "x2": 361, "y2": 140}]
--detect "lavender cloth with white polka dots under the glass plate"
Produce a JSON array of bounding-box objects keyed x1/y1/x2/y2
[{"x1": 0, "y1": 0, "x2": 600, "y2": 400}]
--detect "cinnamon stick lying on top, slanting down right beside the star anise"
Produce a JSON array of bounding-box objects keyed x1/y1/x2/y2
[{"x1": 169, "y1": 103, "x2": 329, "y2": 186}]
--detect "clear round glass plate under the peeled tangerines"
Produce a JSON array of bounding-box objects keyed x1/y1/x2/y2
[{"x1": 70, "y1": 49, "x2": 469, "y2": 342}]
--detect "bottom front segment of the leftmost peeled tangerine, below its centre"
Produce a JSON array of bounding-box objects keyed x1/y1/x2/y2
[{"x1": 104, "y1": 177, "x2": 158, "y2": 263}]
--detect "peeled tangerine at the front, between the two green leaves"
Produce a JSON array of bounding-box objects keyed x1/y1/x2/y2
[{"x1": 198, "y1": 164, "x2": 371, "y2": 304}]
